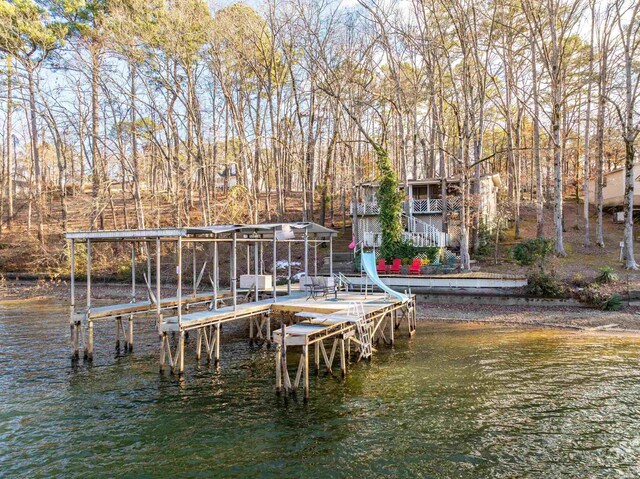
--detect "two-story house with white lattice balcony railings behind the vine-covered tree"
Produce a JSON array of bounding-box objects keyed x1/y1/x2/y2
[{"x1": 351, "y1": 174, "x2": 502, "y2": 248}]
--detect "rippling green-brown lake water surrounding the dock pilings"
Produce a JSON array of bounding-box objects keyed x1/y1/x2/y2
[{"x1": 0, "y1": 301, "x2": 640, "y2": 478}]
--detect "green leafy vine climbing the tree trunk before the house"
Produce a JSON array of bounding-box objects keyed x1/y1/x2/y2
[{"x1": 374, "y1": 145, "x2": 402, "y2": 257}]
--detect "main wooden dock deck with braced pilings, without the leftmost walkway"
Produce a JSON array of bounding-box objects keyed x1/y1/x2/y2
[{"x1": 158, "y1": 292, "x2": 416, "y2": 398}]
